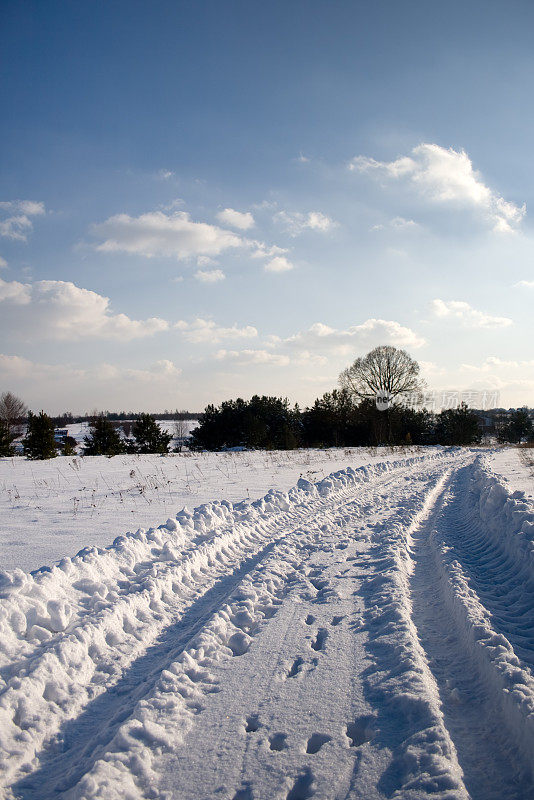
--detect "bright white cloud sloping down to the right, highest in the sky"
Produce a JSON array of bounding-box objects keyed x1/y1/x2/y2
[{"x1": 349, "y1": 144, "x2": 526, "y2": 233}]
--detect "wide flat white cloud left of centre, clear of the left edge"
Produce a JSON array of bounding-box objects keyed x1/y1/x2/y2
[{"x1": 93, "y1": 211, "x2": 246, "y2": 259}]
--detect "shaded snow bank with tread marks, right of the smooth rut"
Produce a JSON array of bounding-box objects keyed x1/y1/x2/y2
[{"x1": 431, "y1": 457, "x2": 534, "y2": 764}]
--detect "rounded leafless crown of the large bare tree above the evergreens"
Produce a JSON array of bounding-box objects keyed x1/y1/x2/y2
[{"x1": 339, "y1": 345, "x2": 423, "y2": 400}]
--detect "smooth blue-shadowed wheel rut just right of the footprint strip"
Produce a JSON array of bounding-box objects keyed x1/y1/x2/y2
[{"x1": 409, "y1": 467, "x2": 534, "y2": 800}]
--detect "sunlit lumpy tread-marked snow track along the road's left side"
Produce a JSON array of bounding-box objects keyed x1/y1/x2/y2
[{"x1": 4, "y1": 453, "x2": 448, "y2": 792}]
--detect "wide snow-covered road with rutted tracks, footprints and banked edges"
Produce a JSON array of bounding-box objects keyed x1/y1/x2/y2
[{"x1": 0, "y1": 450, "x2": 534, "y2": 800}]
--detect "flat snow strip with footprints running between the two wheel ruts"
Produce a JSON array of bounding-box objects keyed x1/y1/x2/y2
[{"x1": 162, "y1": 462, "x2": 474, "y2": 800}]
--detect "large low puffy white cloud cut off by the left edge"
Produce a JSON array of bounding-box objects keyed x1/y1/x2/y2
[{"x1": 0, "y1": 279, "x2": 169, "y2": 341}]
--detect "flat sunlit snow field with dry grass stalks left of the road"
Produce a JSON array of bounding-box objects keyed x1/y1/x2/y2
[{"x1": 0, "y1": 446, "x2": 428, "y2": 572}]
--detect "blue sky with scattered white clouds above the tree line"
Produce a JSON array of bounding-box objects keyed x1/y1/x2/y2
[{"x1": 0, "y1": 0, "x2": 534, "y2": 412}]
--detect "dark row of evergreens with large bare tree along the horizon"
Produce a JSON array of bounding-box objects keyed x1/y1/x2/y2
[{"x1": 0, "y1": 346, "x2": 534, "y2": 458}]
